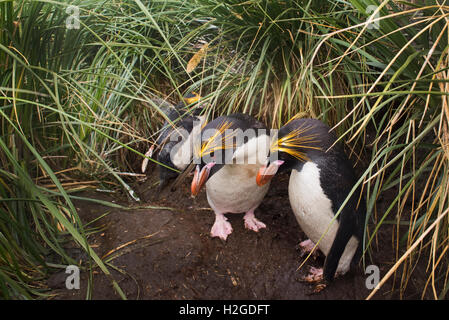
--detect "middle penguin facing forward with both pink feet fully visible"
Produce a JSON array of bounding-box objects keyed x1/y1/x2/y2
[{"x1": 191, "y1": 114, "x2": 270, "y2": 240}]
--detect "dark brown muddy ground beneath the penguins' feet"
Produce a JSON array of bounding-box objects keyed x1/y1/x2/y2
[{"x1": 49, "y1": 168, "x2": 423, "y2": 300}]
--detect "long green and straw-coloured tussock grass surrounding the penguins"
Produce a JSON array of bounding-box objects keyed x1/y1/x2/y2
[{"x1": 0, "y1": 0, "x2": 449, "y2": 299}]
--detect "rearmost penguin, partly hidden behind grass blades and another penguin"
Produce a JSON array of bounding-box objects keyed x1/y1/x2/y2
[{"x1": 142, "y1": 92, "x2": 205, "y2": 190}]
